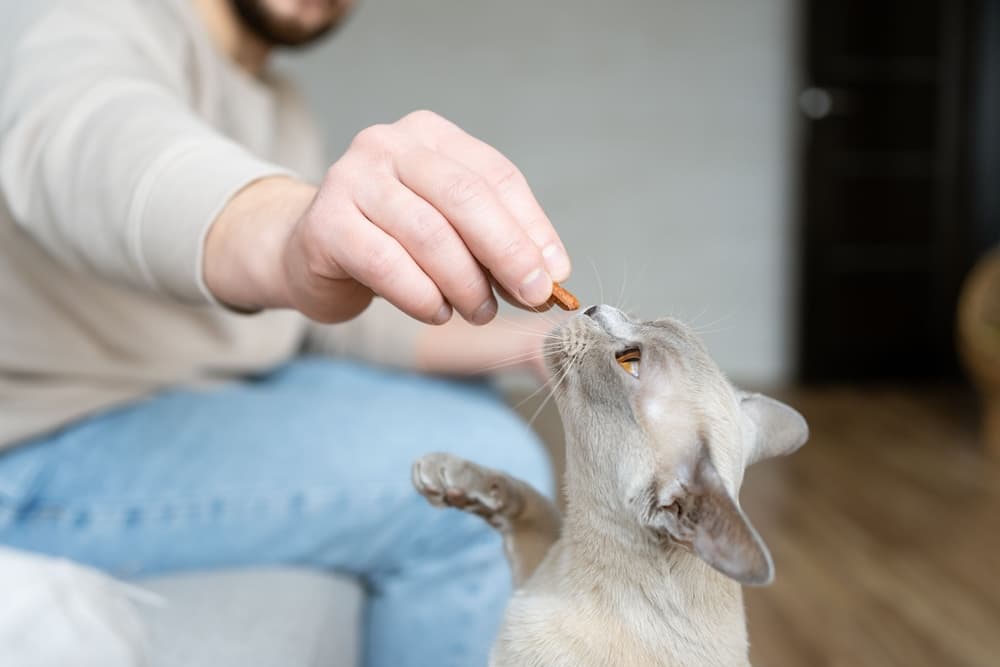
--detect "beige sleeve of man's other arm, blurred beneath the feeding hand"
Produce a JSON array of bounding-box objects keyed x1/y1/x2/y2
[{"x1": 305, "y1": 299, "x2": 429, "y2": 369}]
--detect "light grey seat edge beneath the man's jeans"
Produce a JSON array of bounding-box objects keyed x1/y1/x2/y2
[{"x1": 136, "y1": 568, "x2": 364, "y2": 667}]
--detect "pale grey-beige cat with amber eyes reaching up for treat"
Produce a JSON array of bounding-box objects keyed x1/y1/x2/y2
[{"x1": 412, "y1": 305, "x2": 808, "y2": 667}]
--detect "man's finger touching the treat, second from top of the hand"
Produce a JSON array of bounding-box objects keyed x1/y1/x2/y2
[{"x1": 395, "y1": 146, "x2": 552, "y2": 306}]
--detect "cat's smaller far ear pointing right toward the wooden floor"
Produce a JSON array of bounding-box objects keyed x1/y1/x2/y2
[{"x1": 740, "y1": 393, "x2": 809, "y2": 465}]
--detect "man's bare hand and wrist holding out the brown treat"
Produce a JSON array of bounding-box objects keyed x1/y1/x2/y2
[{"x1": 205, "y1": 111, "x2": 570, "y2": 324}]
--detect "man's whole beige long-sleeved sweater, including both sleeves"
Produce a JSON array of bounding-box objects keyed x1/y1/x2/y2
[{"x1": 0, "y1": 0, "x2": 419, "y2": 447}]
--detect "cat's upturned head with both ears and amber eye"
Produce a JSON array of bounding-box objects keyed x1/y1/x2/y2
[{"x1": 546, "y1": 305, "x2": 809, "y2": 585}]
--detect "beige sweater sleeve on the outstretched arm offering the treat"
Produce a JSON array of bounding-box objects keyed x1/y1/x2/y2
[{"x1": 0, "y1": 3, "x2": 287, "y2": 303}]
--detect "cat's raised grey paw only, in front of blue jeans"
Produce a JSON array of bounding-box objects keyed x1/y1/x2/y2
[{"x1": 412, "y1": 453, "x2": 521, "y2": 523}]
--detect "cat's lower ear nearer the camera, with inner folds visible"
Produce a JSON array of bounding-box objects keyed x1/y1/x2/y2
[{"x1": 647, "y1": 450, "x2": 774, "y2": 586}]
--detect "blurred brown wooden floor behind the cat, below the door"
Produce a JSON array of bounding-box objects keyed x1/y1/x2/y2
[{"x1": 520, "y1": 389, "x2": 1000, "y2": 667}]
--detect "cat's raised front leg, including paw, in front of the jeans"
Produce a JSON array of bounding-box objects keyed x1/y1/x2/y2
[{"x1": 413, "y1": 453, "x2": 561, "y2": 587}]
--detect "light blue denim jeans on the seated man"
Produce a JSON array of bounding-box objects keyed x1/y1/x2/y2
[{"x1": 0, "y1": 358, "x2": 552, "y2": 667}]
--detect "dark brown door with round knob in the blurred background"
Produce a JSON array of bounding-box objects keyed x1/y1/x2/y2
[{"x1": 799, "y1": 0, "x2": 970, "y2": 381}]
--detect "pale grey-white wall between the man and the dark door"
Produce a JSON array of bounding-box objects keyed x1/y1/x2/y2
[{"x1": 278, "y1": 0, "x2": 795, "y2": 384}]
